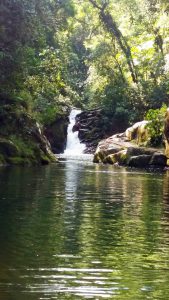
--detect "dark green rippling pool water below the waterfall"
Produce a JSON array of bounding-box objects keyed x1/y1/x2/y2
[{"x1": 0, "y1": 161, "x2": 169, "y2": 300}]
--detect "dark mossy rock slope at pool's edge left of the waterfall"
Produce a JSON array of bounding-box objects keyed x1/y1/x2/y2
[{"x1": 0, "y1": 102, "x2": 57, "y2": 164}]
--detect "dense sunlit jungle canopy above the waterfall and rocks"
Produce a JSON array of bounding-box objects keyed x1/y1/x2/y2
[{"x1": 0, "y1": 0, "x2": 169, "y2": 123}]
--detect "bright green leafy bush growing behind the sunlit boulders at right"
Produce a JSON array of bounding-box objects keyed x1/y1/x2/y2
[{"x1": 145, "y1": 104, "x2": 167, "y2": 146}]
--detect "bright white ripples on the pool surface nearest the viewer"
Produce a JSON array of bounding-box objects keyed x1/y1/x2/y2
[{"x1": 13, "y1": 266, "x2": 127, "y2": 299}]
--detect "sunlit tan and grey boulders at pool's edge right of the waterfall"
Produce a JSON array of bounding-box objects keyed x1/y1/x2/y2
[{"x1": 93, "y1": 121, "x2": 167, "y2": 168}]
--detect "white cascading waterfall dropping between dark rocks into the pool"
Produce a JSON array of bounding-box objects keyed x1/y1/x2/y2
[{"x1": 64, "y1": 109, "x2": 85, "y2": 156}]
